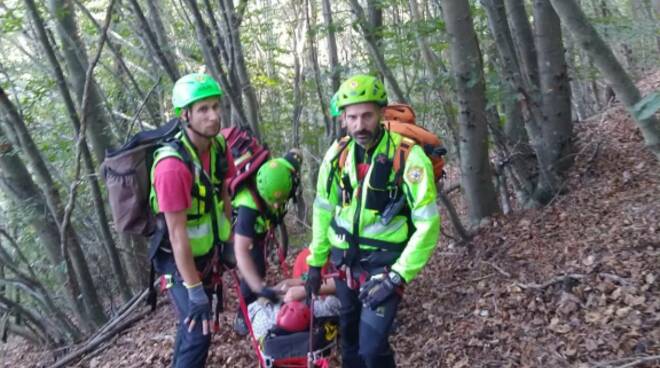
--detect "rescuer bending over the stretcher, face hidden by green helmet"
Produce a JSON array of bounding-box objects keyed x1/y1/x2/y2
[{"x1": 232, "y1": 150, "x2": 302, "y2": 335}]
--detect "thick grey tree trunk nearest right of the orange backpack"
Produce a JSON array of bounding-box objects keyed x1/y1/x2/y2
[{"x1": 442, "y1": 0, "x2": 499, "y2": 225}]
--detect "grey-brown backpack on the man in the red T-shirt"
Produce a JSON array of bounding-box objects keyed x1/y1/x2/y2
[{"x1": 101, "y1": 119, "x2": 192, "y2": 236}]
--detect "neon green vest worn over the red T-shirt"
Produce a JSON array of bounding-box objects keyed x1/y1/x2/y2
[{"x1": 149, "y1": 132, "x2": 231, "y2": 257}]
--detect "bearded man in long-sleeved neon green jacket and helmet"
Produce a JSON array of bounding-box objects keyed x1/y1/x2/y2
[{"x1": 305, "y1": 75, "x2": 440, "y2": 368}]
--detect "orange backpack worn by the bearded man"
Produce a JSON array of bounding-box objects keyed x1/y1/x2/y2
[{"x1": 339, "y1": 104, "x2": 447, "y2": 181}]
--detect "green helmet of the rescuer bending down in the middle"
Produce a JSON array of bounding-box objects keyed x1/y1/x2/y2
[{"x1": 257, "y1": 158, "x2": 295, "y2": 205}]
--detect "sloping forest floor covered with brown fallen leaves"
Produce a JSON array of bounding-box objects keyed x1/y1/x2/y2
[{"x1": 0, "y1": 72, "x2": 660, "y2": 368}]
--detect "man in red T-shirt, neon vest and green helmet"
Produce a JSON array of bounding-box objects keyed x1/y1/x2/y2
[{"x1": 150, "y1": 74, "x2": 235, "y2": 368}]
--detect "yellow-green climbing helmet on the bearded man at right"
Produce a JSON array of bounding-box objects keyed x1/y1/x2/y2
[{"x1": 337, "y1": 74, "x2": 387, "y2": 109}]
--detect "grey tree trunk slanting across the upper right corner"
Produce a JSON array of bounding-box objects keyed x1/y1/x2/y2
[{"x1": 551, "y1": 0, "x2": 660, "y2": 160}]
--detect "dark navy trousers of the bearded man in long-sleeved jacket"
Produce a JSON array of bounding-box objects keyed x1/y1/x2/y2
[{"x1": 335, "y1": 278, "x2": 401, "y2": 368}]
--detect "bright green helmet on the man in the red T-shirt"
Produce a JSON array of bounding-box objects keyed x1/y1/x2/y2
[{"x1": 172, "y1": 73, "x2": 222, "y2": 117}]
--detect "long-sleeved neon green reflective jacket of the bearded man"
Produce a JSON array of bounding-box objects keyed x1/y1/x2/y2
[{"x1": 307, "y1": 131, "x2": 440, "y2": 282}]
